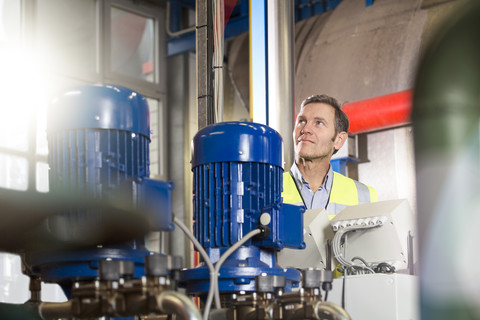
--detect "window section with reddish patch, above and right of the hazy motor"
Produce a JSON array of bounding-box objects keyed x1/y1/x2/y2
[{"x1": 102, "y1": 0, "x2": 166, "y2": 179}]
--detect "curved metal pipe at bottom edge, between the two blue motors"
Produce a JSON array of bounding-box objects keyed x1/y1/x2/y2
[{"x1": 157, "y1": 291, "x2": 202, "y2": 320}]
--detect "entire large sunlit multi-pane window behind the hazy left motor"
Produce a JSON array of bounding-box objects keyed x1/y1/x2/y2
[{"x1": 0, "y1": 0, "x2": 166, "y2": 192}]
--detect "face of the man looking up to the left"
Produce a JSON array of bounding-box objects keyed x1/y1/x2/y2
[{"x1": 293, "y1": 102, "x2": 343, "y2": 160}]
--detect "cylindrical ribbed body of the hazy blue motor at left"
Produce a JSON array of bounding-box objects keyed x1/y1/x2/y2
[{"x1": 47, "y1": 85, "x2": 150, "y2": 199}]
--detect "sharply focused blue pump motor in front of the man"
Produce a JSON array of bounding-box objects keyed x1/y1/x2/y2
[{"x1": 183, "y1": 122, "x2": 305, "y2": 295}]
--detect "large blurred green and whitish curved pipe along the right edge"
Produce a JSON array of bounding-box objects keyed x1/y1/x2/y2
[{"x1": 412, "y1": 0, "x2": 480, "y2": 320}]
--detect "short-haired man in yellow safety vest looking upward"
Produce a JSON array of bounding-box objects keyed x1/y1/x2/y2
[{"x1": 282, "y1": 94, "x2": 378, "y2": 219}]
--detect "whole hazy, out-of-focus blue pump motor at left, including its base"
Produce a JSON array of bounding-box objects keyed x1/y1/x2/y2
[{"x1": 26, "y1": 84, "x2": 173, "y2": 295}]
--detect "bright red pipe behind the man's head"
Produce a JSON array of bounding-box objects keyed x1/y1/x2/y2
[{"x1": 342, "y1": 90, "x2": 413, "y2": 134}]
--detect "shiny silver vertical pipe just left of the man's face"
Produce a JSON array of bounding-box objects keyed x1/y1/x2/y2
[{"x1": 267, "y1": 0, "x2": 295, "y2": 170}]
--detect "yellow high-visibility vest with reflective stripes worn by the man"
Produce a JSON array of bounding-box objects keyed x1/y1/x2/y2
[{"x1": 282, "y1": 171, "x2": 378, "y2": 220}]
